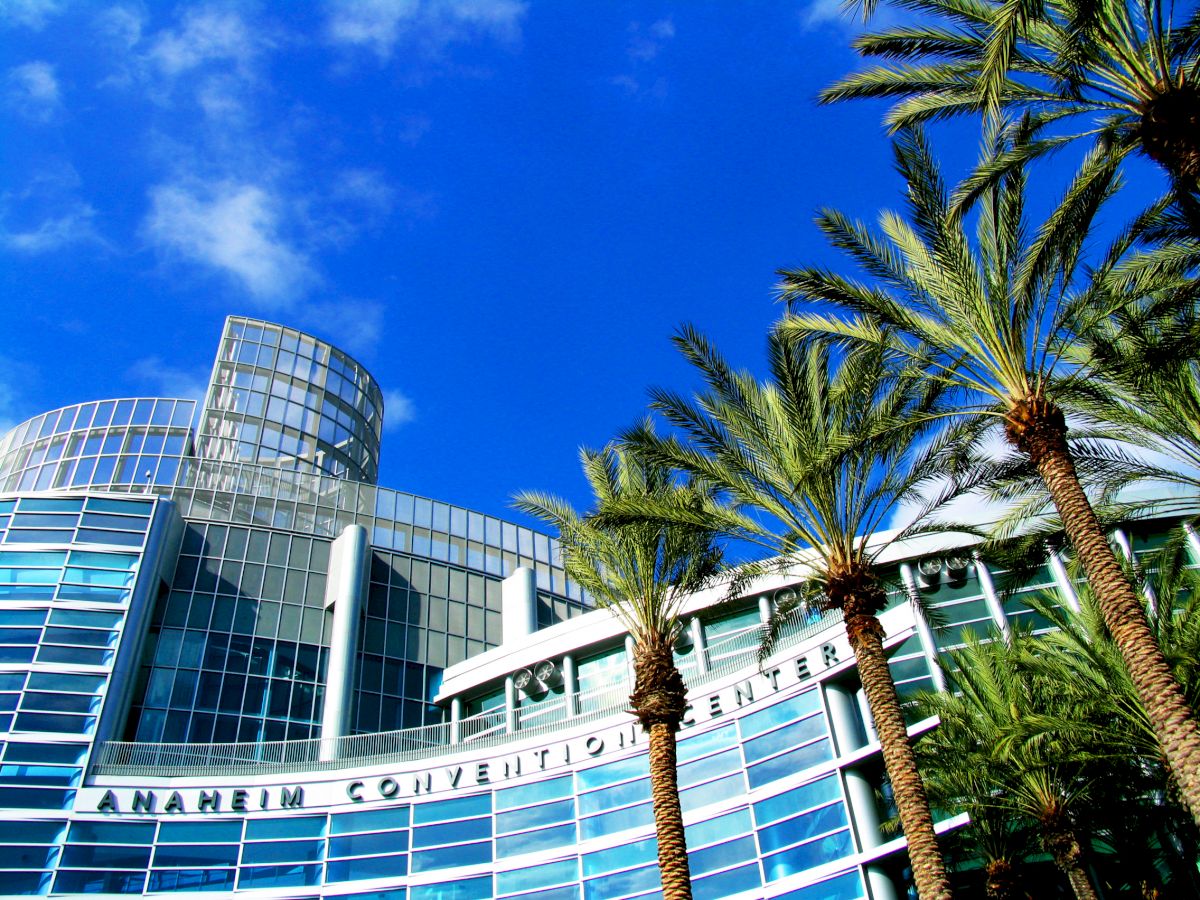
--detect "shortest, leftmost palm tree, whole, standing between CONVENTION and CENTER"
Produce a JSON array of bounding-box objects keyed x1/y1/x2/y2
[{"x1": 514, "y1": 446, "x2": 722, "y2": 900}]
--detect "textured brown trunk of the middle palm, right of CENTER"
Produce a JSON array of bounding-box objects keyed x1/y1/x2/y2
[{"x1": 844, "y1": 604, "x2": 952, "y2": 900}]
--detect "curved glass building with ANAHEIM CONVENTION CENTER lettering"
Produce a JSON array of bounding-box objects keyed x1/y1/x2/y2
[{"x1": 0, "y1": 318, "x2": 1185, "y2": 900}]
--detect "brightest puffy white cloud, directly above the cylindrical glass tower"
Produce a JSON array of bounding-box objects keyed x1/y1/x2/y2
[{"x1": 143, "y1": 181, "x2": 316, "y2": 308}]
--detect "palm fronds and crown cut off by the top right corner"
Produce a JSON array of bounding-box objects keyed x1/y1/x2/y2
[{"x1": 821, "y1": 0, "x2": 1200, "y2": 210}]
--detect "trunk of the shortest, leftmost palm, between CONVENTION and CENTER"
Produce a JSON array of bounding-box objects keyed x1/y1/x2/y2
[{"x1": 629, "y1": 634, "x2": 691, "y2": 900}]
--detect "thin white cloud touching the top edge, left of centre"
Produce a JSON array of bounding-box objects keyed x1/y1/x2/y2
[{"x1": 328, "y1": 0, "x2": 527, "y2": 61}]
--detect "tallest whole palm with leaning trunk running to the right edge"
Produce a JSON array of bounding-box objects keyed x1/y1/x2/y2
[{"x1": 781, "y1": 132, "x2": 1200, "y2": 820}]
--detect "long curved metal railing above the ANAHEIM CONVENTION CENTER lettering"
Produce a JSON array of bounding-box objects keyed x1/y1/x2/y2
[{"x1": 90, "y1": 613, "x2": 839, "y2": 776}]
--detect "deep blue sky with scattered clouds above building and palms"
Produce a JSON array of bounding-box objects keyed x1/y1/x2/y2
[{"x1": 0, "y1": 0, "x2": 1161, "y2": 532}]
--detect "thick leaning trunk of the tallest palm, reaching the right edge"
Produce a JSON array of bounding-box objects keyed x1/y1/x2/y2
[{"x1": 1009, "y1": 401, "x2": 1200, "y2": 824}]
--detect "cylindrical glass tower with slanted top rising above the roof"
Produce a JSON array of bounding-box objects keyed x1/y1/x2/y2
[{"x1": 197, "y1": 317, "x2": 383, "y2": 484}]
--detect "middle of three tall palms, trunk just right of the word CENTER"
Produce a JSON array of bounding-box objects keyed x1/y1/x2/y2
[{"x1": 623, "y1": 328, "x2": 950, "y2": 900}]
